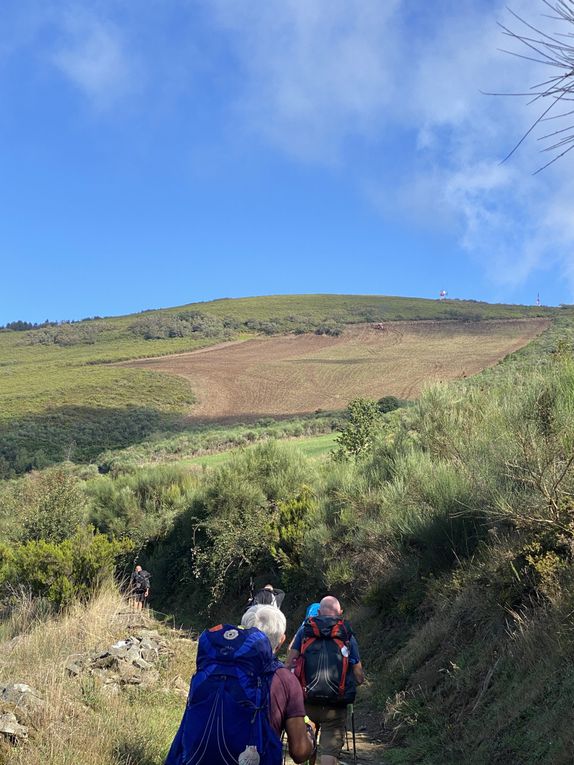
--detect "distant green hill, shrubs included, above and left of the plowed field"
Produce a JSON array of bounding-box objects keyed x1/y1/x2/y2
[{"x1": 0, "y1": 295, "x2": 564, "y2": 475}]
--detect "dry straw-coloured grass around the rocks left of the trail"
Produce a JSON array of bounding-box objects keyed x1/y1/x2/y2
[{"x1": 0, "y1": 587, "x2": 194, "y2": 765}]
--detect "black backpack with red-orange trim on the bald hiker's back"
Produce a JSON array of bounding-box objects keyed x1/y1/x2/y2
[{"x1": 295, "y1": 616, "x2": 357, "y2": 706}]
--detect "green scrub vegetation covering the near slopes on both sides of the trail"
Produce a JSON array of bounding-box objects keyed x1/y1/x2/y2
[{"x1": 0, "y1": 296, "x2": 574, "y2": 765}]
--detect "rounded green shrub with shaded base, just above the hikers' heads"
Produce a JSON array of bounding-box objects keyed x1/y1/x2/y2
[{"x1": 150, "y1": 442, "x2": 316, "y2": 606}]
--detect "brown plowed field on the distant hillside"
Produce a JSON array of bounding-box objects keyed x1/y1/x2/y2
[{"x1": 121, "y1": 319, "x2": 549, "y2": 422}]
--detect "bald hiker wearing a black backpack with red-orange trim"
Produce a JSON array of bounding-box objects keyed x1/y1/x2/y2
[{"x1": 287, "y1": 595, "x2": 365, "y2": 765}]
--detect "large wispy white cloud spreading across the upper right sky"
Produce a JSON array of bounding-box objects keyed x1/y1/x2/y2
[{"x1": 208, "y1": 0, "x2": 574, "y2": 292}]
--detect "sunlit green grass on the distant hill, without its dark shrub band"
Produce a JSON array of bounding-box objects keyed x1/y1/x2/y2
[{"x1": 0, "y1": 295, "x2": 558, "y2": 475}]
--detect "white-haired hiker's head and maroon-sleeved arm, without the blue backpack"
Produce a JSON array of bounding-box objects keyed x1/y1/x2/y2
[{"x1": 241, "y1": 605, "x2": 315, "y2": 762}]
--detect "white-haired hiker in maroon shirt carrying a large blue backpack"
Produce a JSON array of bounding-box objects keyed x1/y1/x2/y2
[{"x1": 165, "y1": 605, "x2": 315, "y2": 765}]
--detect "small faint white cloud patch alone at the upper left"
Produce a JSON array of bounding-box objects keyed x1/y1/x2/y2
[{"x1": 52, "y1": 6, "x2": 138, "y2": 109}]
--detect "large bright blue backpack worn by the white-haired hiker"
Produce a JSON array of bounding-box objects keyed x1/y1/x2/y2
[{"x1": 165, "y1": 624, "x2": 282, "y2": 765}]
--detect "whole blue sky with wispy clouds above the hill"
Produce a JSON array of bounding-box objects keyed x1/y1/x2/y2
[{"x1": 0, "y1": 0, "x2": 574, "y2": 324}]
